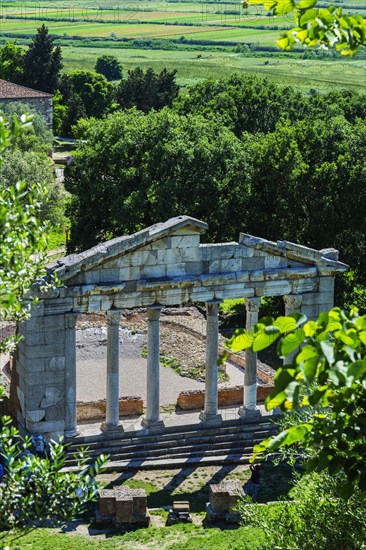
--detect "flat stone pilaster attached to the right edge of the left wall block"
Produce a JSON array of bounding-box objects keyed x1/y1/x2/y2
[{"x1": 65, "y1": 313, "x2": 78, "y2": 437}]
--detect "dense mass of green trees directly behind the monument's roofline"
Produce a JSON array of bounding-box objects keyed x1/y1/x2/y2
[{"x1": 65, "y1": 75, "x2": 366, "y2": 306}]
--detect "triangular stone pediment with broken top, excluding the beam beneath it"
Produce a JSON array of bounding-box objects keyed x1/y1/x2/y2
[{"x1": 50, "y1": 216, "x2": 347, "y2": 288}]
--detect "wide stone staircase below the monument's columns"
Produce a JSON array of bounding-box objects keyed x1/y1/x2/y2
[{"x1": 65, "y1": 418, "x2": 276, "y2": 472}]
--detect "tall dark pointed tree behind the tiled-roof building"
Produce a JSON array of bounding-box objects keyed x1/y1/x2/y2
[{"x1": 23, "y1": 24, "x2": 63, "y2": 93}]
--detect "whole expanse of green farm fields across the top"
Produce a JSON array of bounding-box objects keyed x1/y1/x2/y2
[{"x1": 0, "y1": 0, "x2": 366, "y2": 90}]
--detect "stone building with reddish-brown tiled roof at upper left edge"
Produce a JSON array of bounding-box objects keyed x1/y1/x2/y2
[{"x1": 0, "y1": 79, "x2": 53, "y2": 128}]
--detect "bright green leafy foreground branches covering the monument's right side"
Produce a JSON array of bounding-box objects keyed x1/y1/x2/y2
[{"x1": 228, "y1": 308, "x2": 366, "y2": 502}]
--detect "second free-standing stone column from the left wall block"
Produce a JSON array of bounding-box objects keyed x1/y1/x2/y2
[{"x1": 141, "y1": 306, "x2": 164, "y2": 432}]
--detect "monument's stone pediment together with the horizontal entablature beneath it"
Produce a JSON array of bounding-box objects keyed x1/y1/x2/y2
[{"x1": 45, "y1": 217, "x2": 347, "y2": 317}]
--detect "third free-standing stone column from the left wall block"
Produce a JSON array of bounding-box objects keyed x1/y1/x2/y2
[{"x1": 200, "y1": 300, "x2": 222, "y2": 425}]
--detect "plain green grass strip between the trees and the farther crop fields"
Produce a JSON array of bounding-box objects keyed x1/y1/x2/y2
[{"x1": 63, "y1": 46, "x2": 365, "y2": 91}]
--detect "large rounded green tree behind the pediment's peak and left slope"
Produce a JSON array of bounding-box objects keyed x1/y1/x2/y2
[{"x1": 65, "y1": 108, "x2": 250, "y2": 250}]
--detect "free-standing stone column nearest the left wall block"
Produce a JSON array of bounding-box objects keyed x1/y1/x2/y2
[{"x1": 101, "y1": 310, "x2": 123, "y2": 432}]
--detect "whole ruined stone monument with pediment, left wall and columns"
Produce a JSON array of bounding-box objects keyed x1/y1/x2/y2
[{"x1": 13, "y1": 216, "x2": 348, "y2": 437}]
